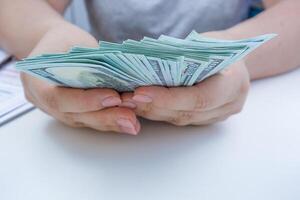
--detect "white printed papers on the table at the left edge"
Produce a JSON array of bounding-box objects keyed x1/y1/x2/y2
[{"x1": 0, "y1": 50, "x2": 33, "y2": 126}]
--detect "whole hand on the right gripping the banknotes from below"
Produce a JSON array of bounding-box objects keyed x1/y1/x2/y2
[{"x1": 122, "y1": 61, "x2": 250, "y2": 126}]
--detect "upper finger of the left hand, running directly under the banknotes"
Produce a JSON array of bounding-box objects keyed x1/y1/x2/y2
[{"x1": 21, "y1": 73, "x2": 121, "y2": 112}]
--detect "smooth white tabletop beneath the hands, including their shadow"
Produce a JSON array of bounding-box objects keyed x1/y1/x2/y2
[{"x1": 0, "y1": 70, "x2": 300, "y2": 200}]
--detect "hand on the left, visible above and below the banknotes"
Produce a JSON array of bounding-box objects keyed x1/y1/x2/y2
[{"x1": 21, "y1": 25, "x2": 140, "y2": 135}]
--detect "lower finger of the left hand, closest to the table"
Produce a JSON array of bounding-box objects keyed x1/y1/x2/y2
[{"x1": 63, "y1": 107, "x2": 140, "y2": 135}]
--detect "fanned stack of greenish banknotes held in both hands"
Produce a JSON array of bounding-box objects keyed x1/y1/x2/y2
[{"x1": 16, "y1": 31, "x2": 275, "y2": 92}]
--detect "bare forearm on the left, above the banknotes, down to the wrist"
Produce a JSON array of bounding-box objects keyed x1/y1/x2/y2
[{"x1": 0, "y1": 0, "x2": 94, "y2": 58}]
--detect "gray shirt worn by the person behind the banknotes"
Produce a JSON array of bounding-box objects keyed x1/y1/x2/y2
[{"x1": 85, "y1": 0, "x2": 251, "y2": 42}]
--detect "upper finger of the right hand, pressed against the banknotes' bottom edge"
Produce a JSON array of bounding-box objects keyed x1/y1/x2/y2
[{"x1": 132, "y1": 62, "x2": 248, "y2": 111}]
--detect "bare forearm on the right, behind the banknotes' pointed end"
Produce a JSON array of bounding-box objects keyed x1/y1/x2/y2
[{"x1": 225, "y1": 0, "x2": 300, "y2": 79}]
